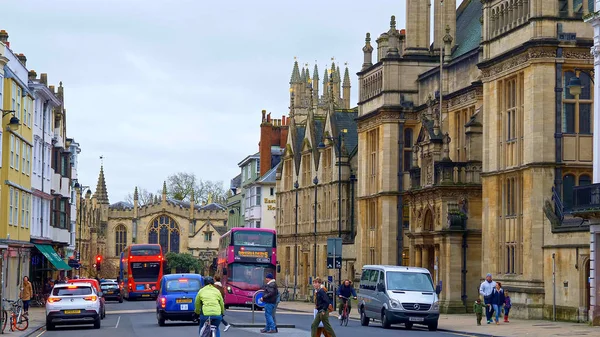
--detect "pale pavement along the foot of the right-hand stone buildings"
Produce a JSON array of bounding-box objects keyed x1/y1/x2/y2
[{"x1": 277, "y1": 301, "x2": 600, "y2": 337}]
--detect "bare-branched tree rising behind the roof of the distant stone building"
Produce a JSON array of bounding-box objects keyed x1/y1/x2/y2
[{"x1": 161, "y1": 172, "x2": 227, "y2": 203}]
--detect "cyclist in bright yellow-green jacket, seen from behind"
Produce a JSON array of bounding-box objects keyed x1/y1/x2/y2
[{"x1": 194, "y1": 276, "x2": 225, "y2": 337}]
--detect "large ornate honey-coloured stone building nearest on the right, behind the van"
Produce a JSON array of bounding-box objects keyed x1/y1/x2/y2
[{"x1": 357, "y1": 0, "x2": 593, "y2": 320}]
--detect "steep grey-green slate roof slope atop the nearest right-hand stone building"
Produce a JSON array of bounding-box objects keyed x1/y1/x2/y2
[{"x1": 450, "y1": 0, "x2": 483, "y2": 59}]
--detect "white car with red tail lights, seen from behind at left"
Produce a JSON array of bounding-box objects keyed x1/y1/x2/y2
[{"x1": 46, "y1": 282, "x2": 100, "y2": 330}]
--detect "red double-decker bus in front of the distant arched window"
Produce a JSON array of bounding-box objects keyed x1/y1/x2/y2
[{"x1": 119, "y1": 244, "x2": 164, "y2": 300}]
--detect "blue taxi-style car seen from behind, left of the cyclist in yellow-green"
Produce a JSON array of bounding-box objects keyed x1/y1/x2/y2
[{"x1": 155, "y1": 274, "x2": 204, "y2": 326}]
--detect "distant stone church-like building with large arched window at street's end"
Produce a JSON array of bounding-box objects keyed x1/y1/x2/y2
[{"x1": 77, "y1": 169, "x2": 227, "y2": 277}]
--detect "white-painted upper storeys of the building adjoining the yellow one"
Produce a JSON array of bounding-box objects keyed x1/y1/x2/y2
[{"x1": 29, "y1": 72, "x2": 61, "y2": 243}]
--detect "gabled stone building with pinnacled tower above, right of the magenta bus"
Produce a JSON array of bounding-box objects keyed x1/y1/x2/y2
[{"x1": 276, "y1": 61, "x2": 360, "y2": 296}]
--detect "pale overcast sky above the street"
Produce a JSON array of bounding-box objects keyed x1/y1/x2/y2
[{"x1": 0, "y1": 0, "x2": 462, "y2": 203}]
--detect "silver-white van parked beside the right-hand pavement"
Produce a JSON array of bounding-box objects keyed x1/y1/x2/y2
[{"x1": 358, "y1": 265, "x2": 442, "y2": 331}]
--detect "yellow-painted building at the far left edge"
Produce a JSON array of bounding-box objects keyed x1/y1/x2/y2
[{"x1": 0, "y1": 36, "x2": 33, "y2": 298}]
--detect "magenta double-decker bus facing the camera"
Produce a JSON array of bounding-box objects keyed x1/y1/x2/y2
[{"x1": 217, "y1": 228, "x2": 279, "y2": 307}]
